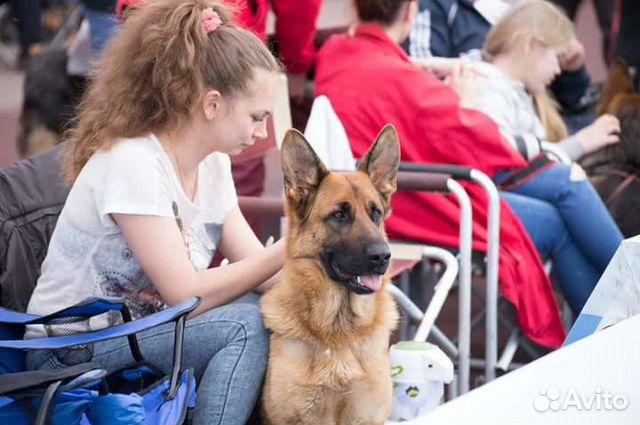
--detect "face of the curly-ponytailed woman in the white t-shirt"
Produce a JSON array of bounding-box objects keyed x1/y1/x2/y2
[{"x1": 211, "y1": 69, "x2": 277, "y2": 155}]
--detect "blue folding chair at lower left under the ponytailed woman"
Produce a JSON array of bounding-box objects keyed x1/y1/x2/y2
[{"x1": 0, "y1": 298, "x2": 200, "y2": 425}]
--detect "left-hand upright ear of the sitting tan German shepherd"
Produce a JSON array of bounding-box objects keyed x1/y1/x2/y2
[{"x1": 280, "y1": 129, "x2": 329, "y2": 217}]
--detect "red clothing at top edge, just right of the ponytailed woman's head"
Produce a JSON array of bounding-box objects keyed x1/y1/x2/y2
[{"x1": 230, "y1": 0, "x2": 322, "y2": 74}]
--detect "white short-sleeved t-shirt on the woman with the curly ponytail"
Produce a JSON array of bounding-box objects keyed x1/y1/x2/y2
[{"x1": 25, "y1": 135, "x2": 237, "y2": 338}]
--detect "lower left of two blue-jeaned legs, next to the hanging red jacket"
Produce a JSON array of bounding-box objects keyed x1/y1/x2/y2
[{"x1": 500, "y1": 191, "x2": 601, "y2": 316}]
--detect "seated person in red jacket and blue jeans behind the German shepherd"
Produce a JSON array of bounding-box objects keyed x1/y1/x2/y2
[{"x1": 316, "y1": 0, "x2": 621, "y2": 347}]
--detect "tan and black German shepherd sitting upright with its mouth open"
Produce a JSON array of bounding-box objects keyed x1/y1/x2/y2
[{"x1": 261, "y1": 126, "x2": 400, "y2": 425}]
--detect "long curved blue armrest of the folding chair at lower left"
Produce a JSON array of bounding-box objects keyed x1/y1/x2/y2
[{"x1": 0, "y1": 297, "x2": 200, "y2": 350}]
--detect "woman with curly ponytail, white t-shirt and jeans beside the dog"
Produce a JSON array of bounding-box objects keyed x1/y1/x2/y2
[{"x1": 26, "y1": 0, "x2": 284, "y2": 425}]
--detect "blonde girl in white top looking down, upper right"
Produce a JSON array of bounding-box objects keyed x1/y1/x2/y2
[{"x1": 475, "y1": 0, "x2": 620, "y2": 160}]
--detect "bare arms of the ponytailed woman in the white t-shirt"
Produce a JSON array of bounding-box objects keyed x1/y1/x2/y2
[{"x1": 113, "y1": 208, "x2": 284, "y2": 315}]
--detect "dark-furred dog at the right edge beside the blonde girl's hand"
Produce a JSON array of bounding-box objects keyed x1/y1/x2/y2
[{"x1": 580, "y1": 61, "x2": 640, "y2": 237}]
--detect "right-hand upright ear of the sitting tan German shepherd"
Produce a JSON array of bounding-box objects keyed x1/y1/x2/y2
[{"x1": 358, "y1": 124, "x2": 400, "y2": 210}]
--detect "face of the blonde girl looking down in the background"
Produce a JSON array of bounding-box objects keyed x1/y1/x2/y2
[{"x1": 522, "y1": 40, "x2": 561, "y2": 93}]
